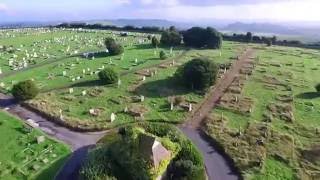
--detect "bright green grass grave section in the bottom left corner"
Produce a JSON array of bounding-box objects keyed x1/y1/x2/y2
[{"x1": 0, "y1": 111, "x2": 71, "y2": 180}]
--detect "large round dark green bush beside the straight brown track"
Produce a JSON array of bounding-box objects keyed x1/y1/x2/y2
[{"x1": 175, "y1": 58, "x2": 218, "y2": 90}]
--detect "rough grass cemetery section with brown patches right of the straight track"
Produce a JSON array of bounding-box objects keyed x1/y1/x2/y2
[{"x1": 204, "y1": 45, "x2": 320, "y2": 180}]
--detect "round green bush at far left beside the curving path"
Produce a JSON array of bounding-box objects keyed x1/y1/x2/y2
[{"x1": 11, "y1": 80, "x2": 39, "y2": 101}]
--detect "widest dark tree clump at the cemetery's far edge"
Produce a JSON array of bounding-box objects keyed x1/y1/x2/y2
[{"x1": 183, "y1": 27, "x2": 222, "y2": 49}]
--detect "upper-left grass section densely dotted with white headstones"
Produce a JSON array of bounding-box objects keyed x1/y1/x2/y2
[{"x1": 0, "y1": 29, "x2": 109, "y2": 75}]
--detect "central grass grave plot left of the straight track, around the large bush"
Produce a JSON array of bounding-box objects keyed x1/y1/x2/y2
[{"x1": 24, "y1": 41, "x2": 240, "y2": 130}]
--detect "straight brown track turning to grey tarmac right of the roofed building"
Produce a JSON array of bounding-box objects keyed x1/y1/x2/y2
[{"x1": 180, "y1": 49, "x2": 253, "y2": 180}]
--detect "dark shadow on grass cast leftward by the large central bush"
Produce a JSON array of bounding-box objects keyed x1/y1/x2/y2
[{"x1": 134, "y1": 78, "x2": 190, "y2": 98}]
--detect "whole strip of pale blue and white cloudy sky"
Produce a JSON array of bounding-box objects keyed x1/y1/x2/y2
[{"x1": 0, "y1": 0, "x2": 320, "y2": 23}]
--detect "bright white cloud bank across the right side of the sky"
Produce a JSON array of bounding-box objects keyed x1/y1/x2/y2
[{"x1": 141, "y1": 0, "x2": 320, "y2": 21}]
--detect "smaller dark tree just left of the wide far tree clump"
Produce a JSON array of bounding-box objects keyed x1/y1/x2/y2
[{"x1": 160, "y1": 29, "x2": 182, "y2": 46}]
